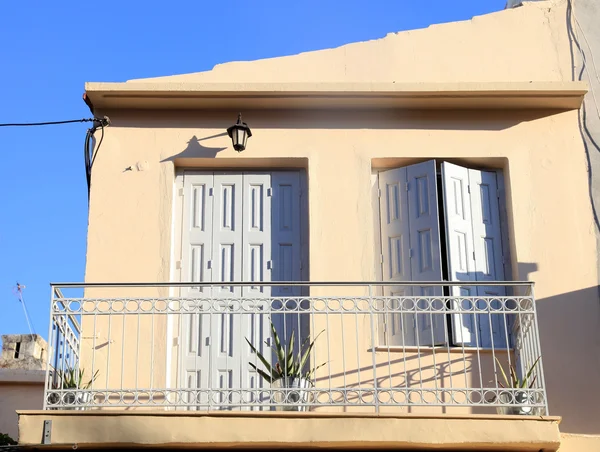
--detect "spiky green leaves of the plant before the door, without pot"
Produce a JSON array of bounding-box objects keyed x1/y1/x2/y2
[{"x1": 246, "y1": 322, "x2": 326, "y2": 383}]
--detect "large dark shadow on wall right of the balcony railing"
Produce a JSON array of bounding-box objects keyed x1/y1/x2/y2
[{"x1": 537, "y1": 286, "x2": 600, "y2": 434}]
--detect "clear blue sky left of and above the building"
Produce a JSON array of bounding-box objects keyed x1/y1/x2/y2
[{"x1": 0, "y1": 0, "x2": 505, "y2": 337}]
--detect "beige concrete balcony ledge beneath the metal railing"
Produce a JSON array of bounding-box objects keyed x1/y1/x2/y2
[{"x1": 18, "y1": 410, "x2": 560, "y2": 452}]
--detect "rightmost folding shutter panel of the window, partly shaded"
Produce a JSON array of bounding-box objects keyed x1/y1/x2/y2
[{"x1": 469, "y1": 169, "x2": 507, "y2": 348}]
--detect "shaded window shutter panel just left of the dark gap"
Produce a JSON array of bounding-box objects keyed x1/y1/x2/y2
[{"x1": 406, "y1": 160, "x2": 445, "y2": 345}]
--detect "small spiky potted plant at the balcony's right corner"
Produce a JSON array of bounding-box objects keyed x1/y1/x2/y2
[{"x1": 495, "y1": 356, "x2": 541, "y2": 415}]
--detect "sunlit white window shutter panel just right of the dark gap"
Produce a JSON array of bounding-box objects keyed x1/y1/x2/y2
[{"x1": 442, "y1": 162, "x2": 477, "y2": 346}]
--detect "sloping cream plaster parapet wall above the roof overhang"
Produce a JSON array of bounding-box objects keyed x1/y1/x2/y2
[{"x1": 129, "y1": 0, "x2": 571, "y2": 83}]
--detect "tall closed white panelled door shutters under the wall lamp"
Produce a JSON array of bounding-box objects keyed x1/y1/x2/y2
[{"x1": 179, "y1": 172, "x2": 302, "y2": 409}]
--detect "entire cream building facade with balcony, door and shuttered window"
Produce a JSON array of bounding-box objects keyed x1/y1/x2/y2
[{"x1": 20, "y1": 0, "x2": 600, "y2": 450}]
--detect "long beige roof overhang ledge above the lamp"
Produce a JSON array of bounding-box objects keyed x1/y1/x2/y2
[{"x1": 85, "y1": 82, "x2": 587, "y2": 110}]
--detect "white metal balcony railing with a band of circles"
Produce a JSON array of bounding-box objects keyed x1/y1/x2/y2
[{"x1": 44, "y1": 282, "x2": 548, "y2": 415}]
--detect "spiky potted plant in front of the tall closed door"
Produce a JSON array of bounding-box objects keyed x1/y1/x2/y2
[{"x1": 246, "y1": 322, "x2": 326, "y2": 411}]
